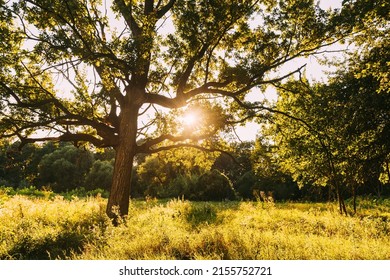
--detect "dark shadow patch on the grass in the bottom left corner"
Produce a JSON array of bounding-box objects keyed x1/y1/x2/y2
[{"x1": 4, "y1": 232, "x2": 86, "y2": 260}]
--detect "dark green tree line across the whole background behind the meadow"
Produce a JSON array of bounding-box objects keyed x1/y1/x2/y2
[{"x1": 0, "y1": 132, "x2": 390, "y2": 205}]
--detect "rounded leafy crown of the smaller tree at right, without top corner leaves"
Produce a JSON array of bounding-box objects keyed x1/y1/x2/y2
[{"x1": 270, "y1": 43, "x2": 390, "y2": 205}]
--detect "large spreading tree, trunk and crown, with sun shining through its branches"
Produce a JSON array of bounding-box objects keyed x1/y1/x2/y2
[{"x1": 0, "y1": 0, "x2": 353, "y2": 216}]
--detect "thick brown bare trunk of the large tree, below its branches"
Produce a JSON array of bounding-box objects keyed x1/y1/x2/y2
[{"x1": 106, "y1": 106, "x2": 138, "y2": 224}]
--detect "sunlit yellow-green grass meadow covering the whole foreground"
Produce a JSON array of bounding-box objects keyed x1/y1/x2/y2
[{"x1": 0, "y1": 191, "x2": 390, "y2": 260}]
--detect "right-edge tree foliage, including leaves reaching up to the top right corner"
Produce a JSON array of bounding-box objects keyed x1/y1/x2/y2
[{"x1": 269, "y1": 1, "x2": 390, "y2": 212}]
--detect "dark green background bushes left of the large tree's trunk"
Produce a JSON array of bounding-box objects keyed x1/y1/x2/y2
[{"x1": 0, "y1": 141, "x2": 117, "y2": 192}]
